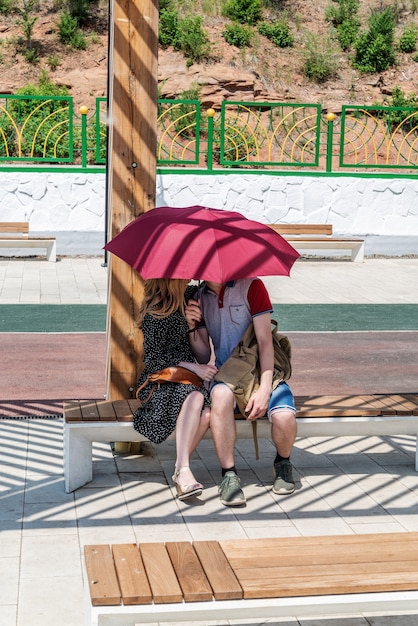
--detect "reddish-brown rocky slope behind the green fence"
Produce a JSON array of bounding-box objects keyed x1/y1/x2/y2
[{"x1": 0, "y1": 0, "x2": 418, "y2": 111}]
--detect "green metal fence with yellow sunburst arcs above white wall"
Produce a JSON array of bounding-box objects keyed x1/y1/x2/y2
[{"x1": 0, "y1": 95, "x2": 418, "y2": 174}]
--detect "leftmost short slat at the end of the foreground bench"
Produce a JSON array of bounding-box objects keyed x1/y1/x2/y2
[{"x1": 84, "y1": 545, "x2": 121, "y2": 606}]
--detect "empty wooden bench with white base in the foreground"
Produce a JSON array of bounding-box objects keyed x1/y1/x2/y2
[{"x1": 84, "y1": 532, "x2": 418, "y2": 626}]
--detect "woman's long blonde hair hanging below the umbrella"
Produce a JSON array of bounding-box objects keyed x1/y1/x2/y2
[{"x1": 137, "y1": 278, "x2": 189, "y2": 328}]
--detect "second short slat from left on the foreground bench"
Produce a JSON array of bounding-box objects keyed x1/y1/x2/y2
[{"x1": 112, "y1": 543, "x2": 152, "y2": 605}]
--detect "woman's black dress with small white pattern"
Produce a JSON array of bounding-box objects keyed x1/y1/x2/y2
[{"x1": 134, "y1": 294, "x2": 210, "y2": 443}]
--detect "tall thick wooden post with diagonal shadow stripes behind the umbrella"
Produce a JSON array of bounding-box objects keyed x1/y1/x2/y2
[{"x1": 106, "y1": 0, "x2": 158, "y2": 400}]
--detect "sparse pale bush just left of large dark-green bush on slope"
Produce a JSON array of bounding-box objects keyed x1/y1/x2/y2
[{"x1": 302, "y1": 33, "x2": 339, "y2": 83}]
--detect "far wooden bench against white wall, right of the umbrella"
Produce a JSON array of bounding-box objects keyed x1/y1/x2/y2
[{"x1": 269, "y1": 224, "x2": 364, "y2": 263}]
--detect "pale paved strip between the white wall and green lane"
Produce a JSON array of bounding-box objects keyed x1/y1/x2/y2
[{"x1": 0, "y1": 257, "x2": 418, "y2": 304}]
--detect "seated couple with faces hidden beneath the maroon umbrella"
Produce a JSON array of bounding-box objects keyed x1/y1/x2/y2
[{"x1": 134, "y1": 278, "x2": 296, "y2": 506}]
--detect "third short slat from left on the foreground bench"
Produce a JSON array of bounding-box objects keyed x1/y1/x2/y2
[{"x1": 139, "y1": 543, "x2": 183, "y2": 604}]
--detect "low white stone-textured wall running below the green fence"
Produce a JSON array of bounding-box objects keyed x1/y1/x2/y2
[{"x1": 0, "y1": 168, "x2": 418, "y2": 256}]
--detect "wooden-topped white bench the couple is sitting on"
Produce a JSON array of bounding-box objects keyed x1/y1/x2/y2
[{"x1": 63, "y1": 394, "x2": 418, "y2": 493}]
